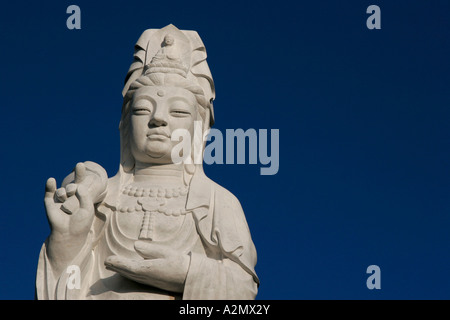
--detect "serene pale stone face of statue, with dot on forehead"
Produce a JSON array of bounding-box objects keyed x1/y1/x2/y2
[{"x1": 130, "y1": 86, "x2": 197, "y2": 164}]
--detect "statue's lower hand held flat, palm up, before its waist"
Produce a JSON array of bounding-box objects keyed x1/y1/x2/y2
[{"x1": 105, "y1": 241, "x2": 190, "y2": 292}]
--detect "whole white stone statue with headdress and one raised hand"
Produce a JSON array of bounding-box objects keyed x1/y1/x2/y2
[{"x1": 36, "y1": 25, "x2": 259, "y2": 299}]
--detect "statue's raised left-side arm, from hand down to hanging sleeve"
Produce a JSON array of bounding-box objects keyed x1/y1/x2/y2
[{"x1": 36, "y1": 161, "x2": 107, "y2": 299}]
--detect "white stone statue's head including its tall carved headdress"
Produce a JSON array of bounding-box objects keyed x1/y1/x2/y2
[{"x1": 119, "y1": 25, "x2": 215, "y2": 172}]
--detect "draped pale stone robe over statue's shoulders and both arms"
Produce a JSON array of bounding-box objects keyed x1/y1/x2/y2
[{"x1": 36, "y1": 170, "x2": 259, "y2": 299}]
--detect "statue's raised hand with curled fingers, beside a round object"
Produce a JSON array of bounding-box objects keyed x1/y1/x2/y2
[{"x1": 44, "y1": 161, "x2": 108, "y2": 270}]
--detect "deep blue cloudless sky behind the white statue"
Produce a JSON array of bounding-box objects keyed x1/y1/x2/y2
[{"x1": 0, "y1": 0, "x2": 450, "y2": 299}]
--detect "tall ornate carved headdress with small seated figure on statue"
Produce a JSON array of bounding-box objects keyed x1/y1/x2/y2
[{"x1": 122, "y1": 24, "x2": 215, "y2": 126}]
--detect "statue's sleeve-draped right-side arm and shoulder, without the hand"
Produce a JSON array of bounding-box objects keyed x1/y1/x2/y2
[{"x1": 183, "y1": 187, "x2": 259, "y2": 300}]
